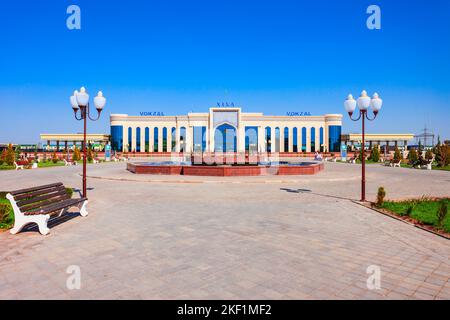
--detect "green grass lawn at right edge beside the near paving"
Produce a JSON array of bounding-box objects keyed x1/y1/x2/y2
[{"x1": 381, "y1": 198, "x2": 450, "y2": 233}]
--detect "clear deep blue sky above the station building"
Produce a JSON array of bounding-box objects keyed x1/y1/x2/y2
[{"x1": 0, "y1": 0, "x2": 450, "y2": 143}]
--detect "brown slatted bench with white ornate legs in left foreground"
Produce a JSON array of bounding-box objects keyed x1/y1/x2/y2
[{"x1": 6, "y1": 182, "x2": 88, "y2": 235}]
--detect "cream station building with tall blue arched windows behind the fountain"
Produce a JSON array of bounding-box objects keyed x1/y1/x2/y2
[{"x1": 110, "y1": 107, "x2": 342, "y2": 153}]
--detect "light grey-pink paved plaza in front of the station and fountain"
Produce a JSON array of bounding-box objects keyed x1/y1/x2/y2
[{"x1": 0, "y1": 163, "x2": 450, "y2": 299}]
